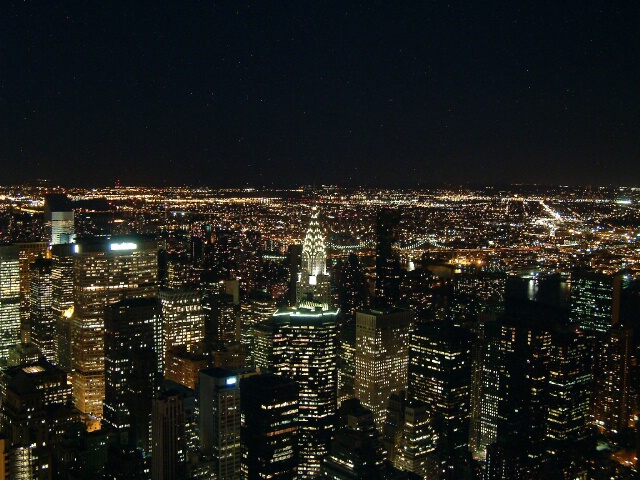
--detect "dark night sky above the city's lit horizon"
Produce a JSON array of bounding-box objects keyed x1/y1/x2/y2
[{"x1": 0, "y1": 0, "x2": 640, "y2": 187}]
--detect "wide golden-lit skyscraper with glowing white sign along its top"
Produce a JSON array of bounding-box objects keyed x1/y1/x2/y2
[{"x1": 72, "y1": 237, "x2": 158, "y2": 418}]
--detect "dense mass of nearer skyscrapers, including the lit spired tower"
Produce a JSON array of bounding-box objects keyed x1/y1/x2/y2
[{"x1": 0, "y1": 197, "x2": 638, "y2": 480}]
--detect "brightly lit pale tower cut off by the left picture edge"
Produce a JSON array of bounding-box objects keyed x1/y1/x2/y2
[{"x1": 0, "y1": 245, "x2": 20, "y2": 365}]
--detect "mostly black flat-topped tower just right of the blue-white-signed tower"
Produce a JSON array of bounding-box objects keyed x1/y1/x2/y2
[{"x1": 240, "y1": 374, "x2": 299, "y2": 480}]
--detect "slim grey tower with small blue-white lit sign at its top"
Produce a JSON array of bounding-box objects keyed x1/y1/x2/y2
[{"x1": 199, "y1": 368, "x2": 241, "y2": 480}]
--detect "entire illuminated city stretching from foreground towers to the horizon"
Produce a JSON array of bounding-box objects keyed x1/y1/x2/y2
[{"x1": 0, "y1": 186, "x2": 640, "y2": 480}]
